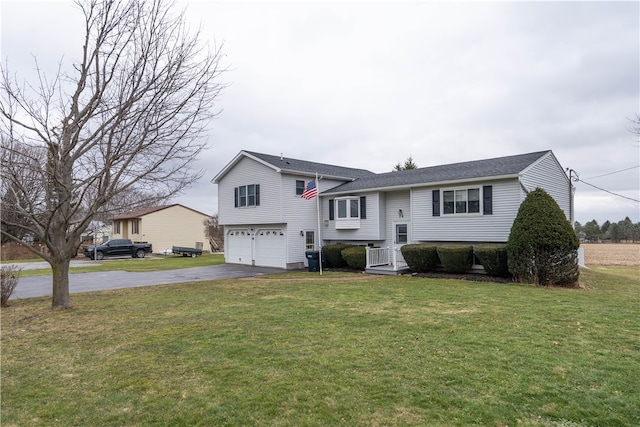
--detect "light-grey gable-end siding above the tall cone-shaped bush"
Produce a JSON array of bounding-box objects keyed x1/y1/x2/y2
[{"x1": 521, "y1": 153, "x2": 570, "y2": 220}]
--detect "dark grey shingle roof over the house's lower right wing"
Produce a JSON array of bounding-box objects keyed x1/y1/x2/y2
[{"x1": 322, "y1": 151, "x2": 551, "y2": 194}]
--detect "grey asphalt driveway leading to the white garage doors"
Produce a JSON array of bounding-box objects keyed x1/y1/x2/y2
[{"x1": 12, "y1": 264, "x2": 287, "y2": 299}]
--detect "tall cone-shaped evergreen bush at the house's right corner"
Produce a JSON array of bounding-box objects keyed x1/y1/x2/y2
[{"x1": 507, "y1": 188, "x2": 580, "y2": 286}]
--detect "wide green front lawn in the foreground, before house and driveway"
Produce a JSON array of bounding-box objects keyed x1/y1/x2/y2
[{"x1": 1, "y1": 269, "x2": 640, "y2": 426}]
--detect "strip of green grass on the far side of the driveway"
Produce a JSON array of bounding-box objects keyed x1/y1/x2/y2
[{"x1": 11, "y1": 254, "x2": 224, "y2": 277}]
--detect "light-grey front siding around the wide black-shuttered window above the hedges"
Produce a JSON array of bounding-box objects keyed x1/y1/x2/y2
[{"x1": 411, "y1": 179, "x2": 521, "y2": 242}]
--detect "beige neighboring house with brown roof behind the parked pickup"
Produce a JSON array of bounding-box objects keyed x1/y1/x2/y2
[{"x1": 111, "y1": 204, "x2": 209, "y2": 252}]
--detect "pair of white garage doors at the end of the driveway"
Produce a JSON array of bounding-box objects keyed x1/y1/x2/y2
[{"x1": 225, "y1": 228, "x2": 287, "y2": 268}]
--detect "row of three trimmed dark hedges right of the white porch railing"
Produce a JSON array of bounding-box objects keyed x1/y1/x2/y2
[{"x1": 401, "y1": 244, "x2": 510, "y2": 277}]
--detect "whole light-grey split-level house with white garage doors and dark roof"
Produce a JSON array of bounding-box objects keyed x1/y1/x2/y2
[{"x1": 212, "y1": 151, "x2": 571, "y2": 269}]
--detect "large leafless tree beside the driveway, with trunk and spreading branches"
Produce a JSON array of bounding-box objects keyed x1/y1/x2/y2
[{"x1": 0, "y1": 0, "x2": 224, "y2": 308}]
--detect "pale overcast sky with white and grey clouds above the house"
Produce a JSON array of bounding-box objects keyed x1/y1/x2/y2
[{"x1": 1, "y1": 0, "x2": 640, "y2": 224}]
